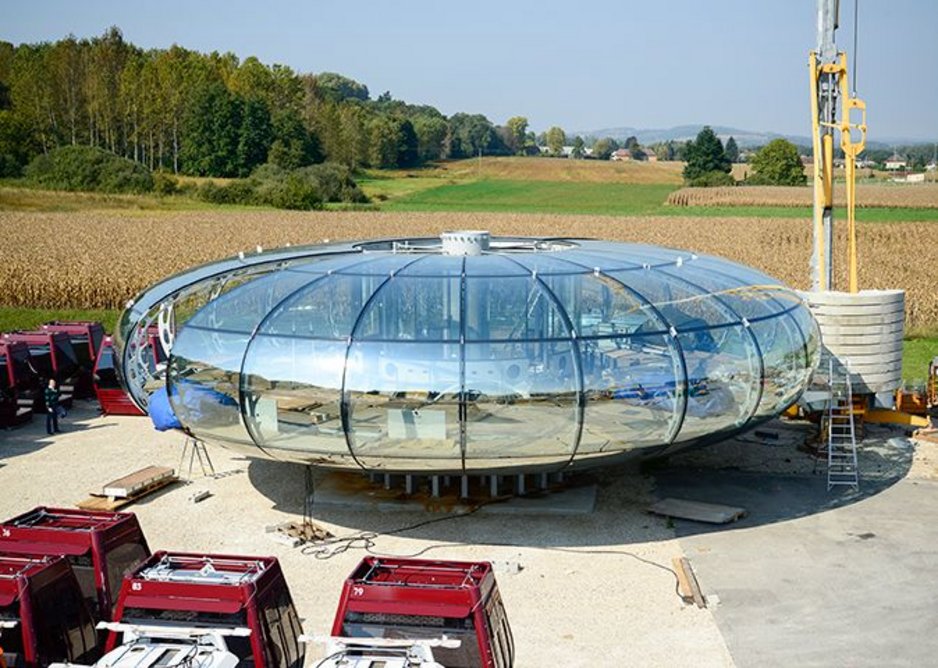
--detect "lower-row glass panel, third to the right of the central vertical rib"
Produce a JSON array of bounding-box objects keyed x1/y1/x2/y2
[{"x1": 678, "y1": 327, "x2": 759, "y2": 441}]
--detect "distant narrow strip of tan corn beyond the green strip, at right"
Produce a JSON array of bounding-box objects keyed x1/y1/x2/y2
[{"x1": 668, "y1": 183, "x2": 938, "y2": 209}]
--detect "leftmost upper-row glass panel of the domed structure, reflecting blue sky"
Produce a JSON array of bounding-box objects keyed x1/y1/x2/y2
[{"x1": 187, "y1": 271, "x2": 315, "y2": 334}]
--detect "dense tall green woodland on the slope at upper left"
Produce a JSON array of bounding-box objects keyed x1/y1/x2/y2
[{"x1": 0, "y1": 27, "x2": 530, "y2": 177}]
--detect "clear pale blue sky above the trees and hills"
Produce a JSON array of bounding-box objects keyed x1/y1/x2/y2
[{"x1": 0, "y1": 0, "x2": 938, "y2": 141}]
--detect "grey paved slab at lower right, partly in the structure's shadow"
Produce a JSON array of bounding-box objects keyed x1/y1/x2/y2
[{"x1": 658, "y1": 471, "x2": 938, "y2": 668}]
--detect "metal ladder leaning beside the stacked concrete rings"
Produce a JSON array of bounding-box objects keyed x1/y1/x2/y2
[{"x1": 827, "y1": 359, "x2": 860, "y2": 491}]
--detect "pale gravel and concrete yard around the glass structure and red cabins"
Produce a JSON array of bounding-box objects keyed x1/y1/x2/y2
[{"x1": 0, "y1": 403, "x2": 938, "y2": 668}]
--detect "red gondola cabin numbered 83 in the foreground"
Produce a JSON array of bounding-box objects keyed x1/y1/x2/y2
[{"x1": 105, "y1": 552, "x2": 305, "y2": 668}]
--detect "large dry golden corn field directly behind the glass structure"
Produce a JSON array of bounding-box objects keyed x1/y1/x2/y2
[{"x1": 0, "y1": 211, "x2": 938, "y2": 329}]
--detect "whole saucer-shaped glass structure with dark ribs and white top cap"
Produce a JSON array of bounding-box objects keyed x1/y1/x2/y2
[{"x1": 117, "y1": 233, "x2": 819, "y2": 474}]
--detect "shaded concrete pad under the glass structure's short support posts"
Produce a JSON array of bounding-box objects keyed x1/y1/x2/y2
[{"x1": 313, "y1": 472, "x2": 597, "y2": 516}]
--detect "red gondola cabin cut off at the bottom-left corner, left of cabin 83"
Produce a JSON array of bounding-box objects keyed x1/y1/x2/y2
[{"x1": 0, "y1": 555, "x2": 98, "y2": 668}]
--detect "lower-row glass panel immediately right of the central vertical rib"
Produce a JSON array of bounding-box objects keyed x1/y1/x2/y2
[{"x1": 466, "y1": 341, "x2": 578, "y2": 469}]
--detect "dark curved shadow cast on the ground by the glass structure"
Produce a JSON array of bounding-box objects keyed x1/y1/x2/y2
[{"x1": 248, "y1": 420, "x2": 912, "y2": 547}]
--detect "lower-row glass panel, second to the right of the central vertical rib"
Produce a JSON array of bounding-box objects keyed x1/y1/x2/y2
[{"x1": 577, "y1": 336, "x2": 683, "y2": 458}]
